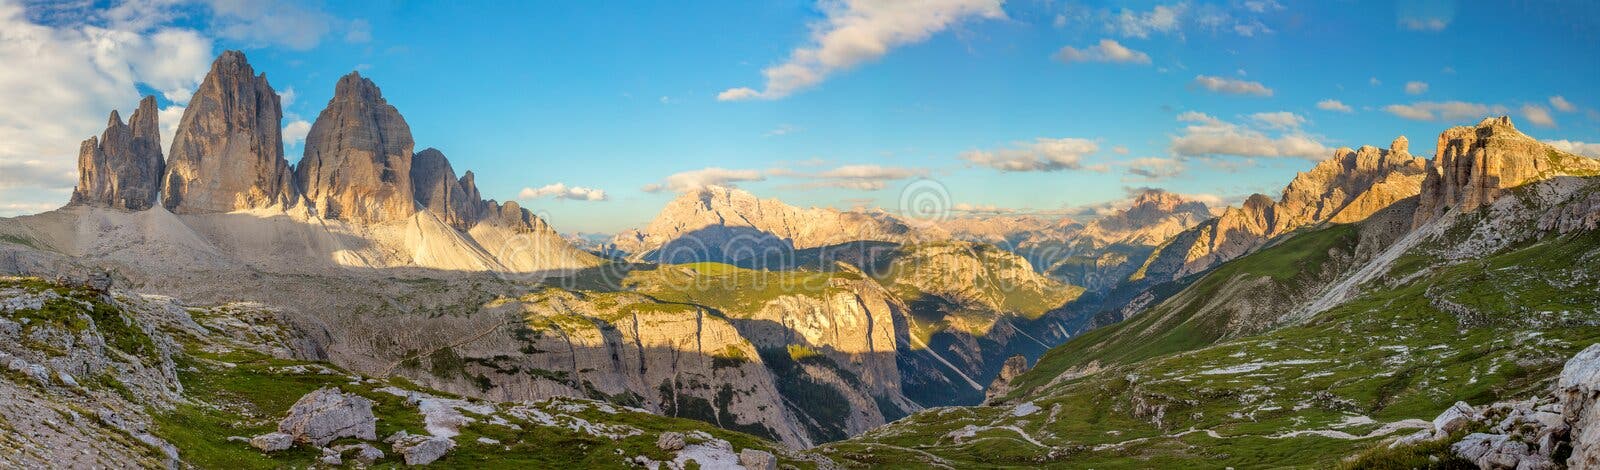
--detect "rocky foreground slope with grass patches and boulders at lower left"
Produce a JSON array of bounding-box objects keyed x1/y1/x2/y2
[{"x1": 0, "y1": 278, "x2": 812, "y2": 468}]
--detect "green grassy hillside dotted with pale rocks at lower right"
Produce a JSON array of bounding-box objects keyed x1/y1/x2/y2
[{"x1": 821, "y1": 215, "x2": 1600, "y2": 468}]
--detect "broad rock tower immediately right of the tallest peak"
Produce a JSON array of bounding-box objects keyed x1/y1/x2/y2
[{"x1": 294, "y1": 72, "x2": 416, "y2": 222}]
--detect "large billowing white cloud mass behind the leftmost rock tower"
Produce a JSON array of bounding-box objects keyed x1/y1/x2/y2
[{"x1": 0, "y1": 2, "x2": 211, "y2": 214}]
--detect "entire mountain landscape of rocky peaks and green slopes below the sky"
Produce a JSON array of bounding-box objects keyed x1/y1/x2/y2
[{"x1": 0, "y1": 51, "x2": 1600, "y2": 468}]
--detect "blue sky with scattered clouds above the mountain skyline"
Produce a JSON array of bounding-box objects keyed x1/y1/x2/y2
[{"x1": 0, "y1": 0, "x2": 1600, "y2": 232}]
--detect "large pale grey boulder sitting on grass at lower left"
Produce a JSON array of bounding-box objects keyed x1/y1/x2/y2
[{"x1": 278, "y1": 387, "x2": 378, "y2": 446}]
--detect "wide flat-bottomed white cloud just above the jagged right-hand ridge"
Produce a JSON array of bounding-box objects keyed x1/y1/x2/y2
[{"x1": 1171, "y1": 112, "x2": 1331, "y2": 160}]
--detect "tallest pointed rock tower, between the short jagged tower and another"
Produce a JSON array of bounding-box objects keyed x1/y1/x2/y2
[{"x1": 162, "y1": 51, "x2": 299, "y2": 214}]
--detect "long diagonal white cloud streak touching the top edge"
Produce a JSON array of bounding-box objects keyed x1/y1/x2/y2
[{"x1": 717, "y1": 0, "x2": 1005, "y2": 101}]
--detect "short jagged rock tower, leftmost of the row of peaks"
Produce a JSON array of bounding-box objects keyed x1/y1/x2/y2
[{"x1": 72, "y1": 96, "x2": 166, "y2": 211}]
